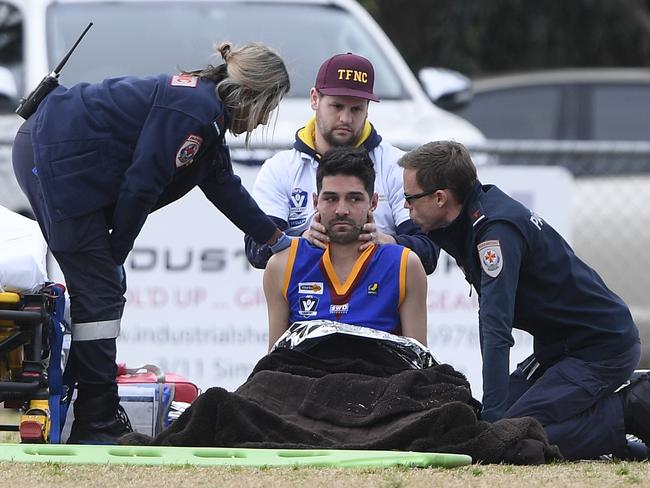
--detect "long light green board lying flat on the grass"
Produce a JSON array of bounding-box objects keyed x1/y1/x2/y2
[{"x1": 0, "y1": 444, "x2": 472, "y2": 468}]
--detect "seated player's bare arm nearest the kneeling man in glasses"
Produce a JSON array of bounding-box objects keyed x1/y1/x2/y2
[{"x1": 399, "y1": 252, "x2": 427, "y2": 346}]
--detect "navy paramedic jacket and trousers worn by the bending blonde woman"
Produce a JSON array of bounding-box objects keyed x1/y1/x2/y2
[{"x1": 13, "y1": 75, "x2": 276, "y2": 395}]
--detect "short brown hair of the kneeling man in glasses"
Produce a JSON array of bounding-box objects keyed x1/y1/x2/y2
[{"x1": 398, "y1": 141, "x2": 477, "y2": 203}]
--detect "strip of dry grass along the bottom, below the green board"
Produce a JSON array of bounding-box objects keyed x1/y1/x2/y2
[{"x1": 0, "y1": 462, "x2": 650, "y2": 488}]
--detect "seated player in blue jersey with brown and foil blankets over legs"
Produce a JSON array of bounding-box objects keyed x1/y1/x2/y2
[{"x1": 120, "y1": 148, "x2": 561, "y2": 464}]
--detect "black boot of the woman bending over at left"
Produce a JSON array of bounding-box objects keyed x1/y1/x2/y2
[{"x1": 68, "y1": 391, "x2": 133, "y2": 444}]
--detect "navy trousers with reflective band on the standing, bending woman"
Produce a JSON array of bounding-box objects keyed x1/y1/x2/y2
[{"x1": 12, "y1": 121, "x2": 126, "y2": 396}]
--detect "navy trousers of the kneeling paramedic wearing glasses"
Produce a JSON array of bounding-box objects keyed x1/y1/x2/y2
[{"x1": 505, "y1": 343, "x2": 641, "y2": 460}]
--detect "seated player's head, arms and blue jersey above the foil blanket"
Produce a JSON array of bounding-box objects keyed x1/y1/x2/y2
[{"x1": 264, "y1": 143, "x2": 427, "y2": 346}]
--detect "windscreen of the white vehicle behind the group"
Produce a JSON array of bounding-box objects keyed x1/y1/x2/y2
[{"x1": 47, "y1": 1, "x2": 407, "y2": 99}]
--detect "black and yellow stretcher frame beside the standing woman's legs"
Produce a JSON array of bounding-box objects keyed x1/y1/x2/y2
[{"x1": 0, "y1": 284, "x2": 67, "y2": 444}]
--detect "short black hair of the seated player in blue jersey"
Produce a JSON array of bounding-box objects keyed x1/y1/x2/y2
[{"x1": 316, "y1": 146, "x2": 375, "y2": 198}]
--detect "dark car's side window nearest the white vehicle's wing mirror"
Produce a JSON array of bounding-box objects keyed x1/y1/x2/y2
[{"x1": 457, "y1": 86, "x2": 561, "y2": 139}]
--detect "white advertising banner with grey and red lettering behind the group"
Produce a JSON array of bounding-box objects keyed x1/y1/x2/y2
[{"x1": 110, "y1": 165, "x2": 573, "y2": 399}]
